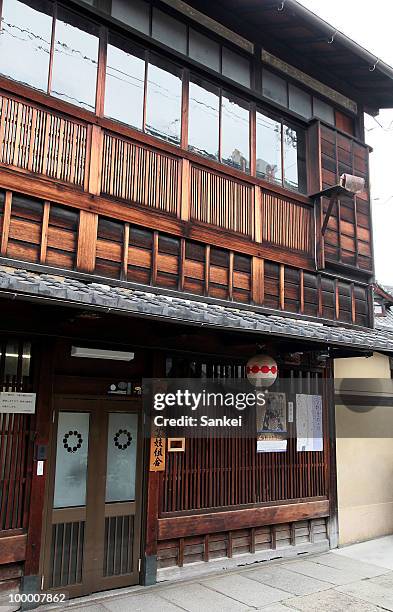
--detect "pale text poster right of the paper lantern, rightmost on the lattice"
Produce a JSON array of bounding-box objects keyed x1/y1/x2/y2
[{"x1": 296, "y1": 393, "x2": 323, "y2": 452}]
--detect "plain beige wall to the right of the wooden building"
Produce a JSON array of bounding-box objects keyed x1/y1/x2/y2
[{"x1": 335, "y1": 353, "x2": 393, "y2": 545}]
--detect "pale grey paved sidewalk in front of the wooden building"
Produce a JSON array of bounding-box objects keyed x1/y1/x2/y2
[{"x1": 35, "y1": 536, "x2": 393, "y2": 612}]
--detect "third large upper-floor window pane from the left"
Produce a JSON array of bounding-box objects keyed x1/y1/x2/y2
[{"x1": 105, "y1": 36, "x2": 145, "y2": 130}]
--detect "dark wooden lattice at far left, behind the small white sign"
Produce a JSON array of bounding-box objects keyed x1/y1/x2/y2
[{"x1": 0, "y1": 340, "x2": 31, "y2": 531}]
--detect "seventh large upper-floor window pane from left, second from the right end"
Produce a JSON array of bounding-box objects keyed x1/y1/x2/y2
[{"x1": 256, "y1": 113, "x2": 282, "y2": 185}]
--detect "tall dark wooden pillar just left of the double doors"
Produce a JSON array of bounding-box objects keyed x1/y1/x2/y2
[{"x1": 21, "y1": 340, "x2": 55, "y2": 593}]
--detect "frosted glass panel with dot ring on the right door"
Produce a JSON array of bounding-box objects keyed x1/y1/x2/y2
[{"x1": 105, "y1": 412, "x2": 138, "y2": 503}]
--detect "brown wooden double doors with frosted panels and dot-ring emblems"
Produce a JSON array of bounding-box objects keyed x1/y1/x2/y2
[{"x1": 43, "y1": 397, "x2": 142, "y2": 597}]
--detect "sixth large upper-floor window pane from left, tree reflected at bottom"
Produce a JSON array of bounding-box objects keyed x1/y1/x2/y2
[{"x1": 221, "y1": 92, "x2": 250, "y2": 171}]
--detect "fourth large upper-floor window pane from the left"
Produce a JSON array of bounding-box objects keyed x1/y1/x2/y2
[{"x1": 146, "y1": 59, "x2": 182, "y2": 144}]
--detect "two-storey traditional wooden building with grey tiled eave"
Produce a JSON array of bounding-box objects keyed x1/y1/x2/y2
[{"x1": 0, "y1": 0, "x2": 393, "y2": 596}]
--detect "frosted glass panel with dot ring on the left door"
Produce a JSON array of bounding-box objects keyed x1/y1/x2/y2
[{"x1": 53, "y1": 412, "x2": 89, "y2": 508}]
